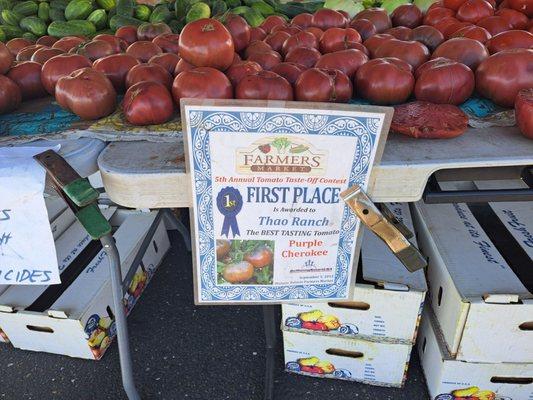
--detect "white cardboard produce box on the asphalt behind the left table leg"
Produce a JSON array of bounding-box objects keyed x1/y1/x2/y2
[{"x1": 0, "y1": 209, "x2": 170, "y2": 359}]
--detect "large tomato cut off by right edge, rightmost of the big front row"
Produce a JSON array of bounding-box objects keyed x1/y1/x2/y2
[{"x1": 476, "y1": 49, "x2": 533, "y2": 107}]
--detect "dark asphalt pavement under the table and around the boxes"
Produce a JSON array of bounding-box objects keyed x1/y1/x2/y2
[{"x1": 0, "y1": 232, "x2": 428, "y2": 400}]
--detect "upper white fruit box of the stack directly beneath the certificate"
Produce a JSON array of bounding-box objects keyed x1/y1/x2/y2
[{"x1": 282, "y1": 203, "x2": 427, "y2": 344}]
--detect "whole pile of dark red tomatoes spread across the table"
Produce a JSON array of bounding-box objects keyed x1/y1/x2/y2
[{"x1": 0, "y1": 0, "x2": 533, "y2": 137}]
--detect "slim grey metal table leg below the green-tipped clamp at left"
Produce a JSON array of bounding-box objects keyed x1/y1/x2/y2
[{"x1": 100, "y1": 235, "x2": 141, "y2": 400}]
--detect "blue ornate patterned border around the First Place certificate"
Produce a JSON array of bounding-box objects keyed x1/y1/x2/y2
[{"x1": 185, "y1": 106, "x2": 385, "y2": 302}]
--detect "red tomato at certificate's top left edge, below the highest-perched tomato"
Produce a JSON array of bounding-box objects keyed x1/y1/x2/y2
[{"x1": 172, "y1": 67, "x2": 233, "y2": 106}]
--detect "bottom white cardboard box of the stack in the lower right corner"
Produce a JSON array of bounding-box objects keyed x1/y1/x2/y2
[{"x1": 418, "y1": 307, "x2": 533, "y2": 400}]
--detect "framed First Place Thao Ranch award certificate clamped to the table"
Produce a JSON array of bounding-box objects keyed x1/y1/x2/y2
[{"x1": 181, "y1": 99, "x2": 392, "y2": 304}]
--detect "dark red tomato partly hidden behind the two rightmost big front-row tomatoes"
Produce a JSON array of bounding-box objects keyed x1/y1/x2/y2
[{"x1": 431, "y1": 38, "x2": 489, "y2": 71}]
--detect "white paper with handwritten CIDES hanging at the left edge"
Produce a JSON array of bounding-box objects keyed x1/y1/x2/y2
[{"x1": 0, "y1": 147, "x2": 60, "y2": 285}]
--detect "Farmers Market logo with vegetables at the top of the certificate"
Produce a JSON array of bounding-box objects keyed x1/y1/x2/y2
[{"x1": 235, "y1": 135, "x2": 327, "y2": 175}]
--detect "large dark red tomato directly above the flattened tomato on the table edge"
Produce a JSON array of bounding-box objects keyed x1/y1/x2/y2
[{"x1": 415, "y1": 58, "x2": 475, "y2": 105}]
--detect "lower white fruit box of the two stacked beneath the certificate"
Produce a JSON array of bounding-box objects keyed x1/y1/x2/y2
[{"x1": 283, "y1": 331, "x2": 412, "y2": 387}]
